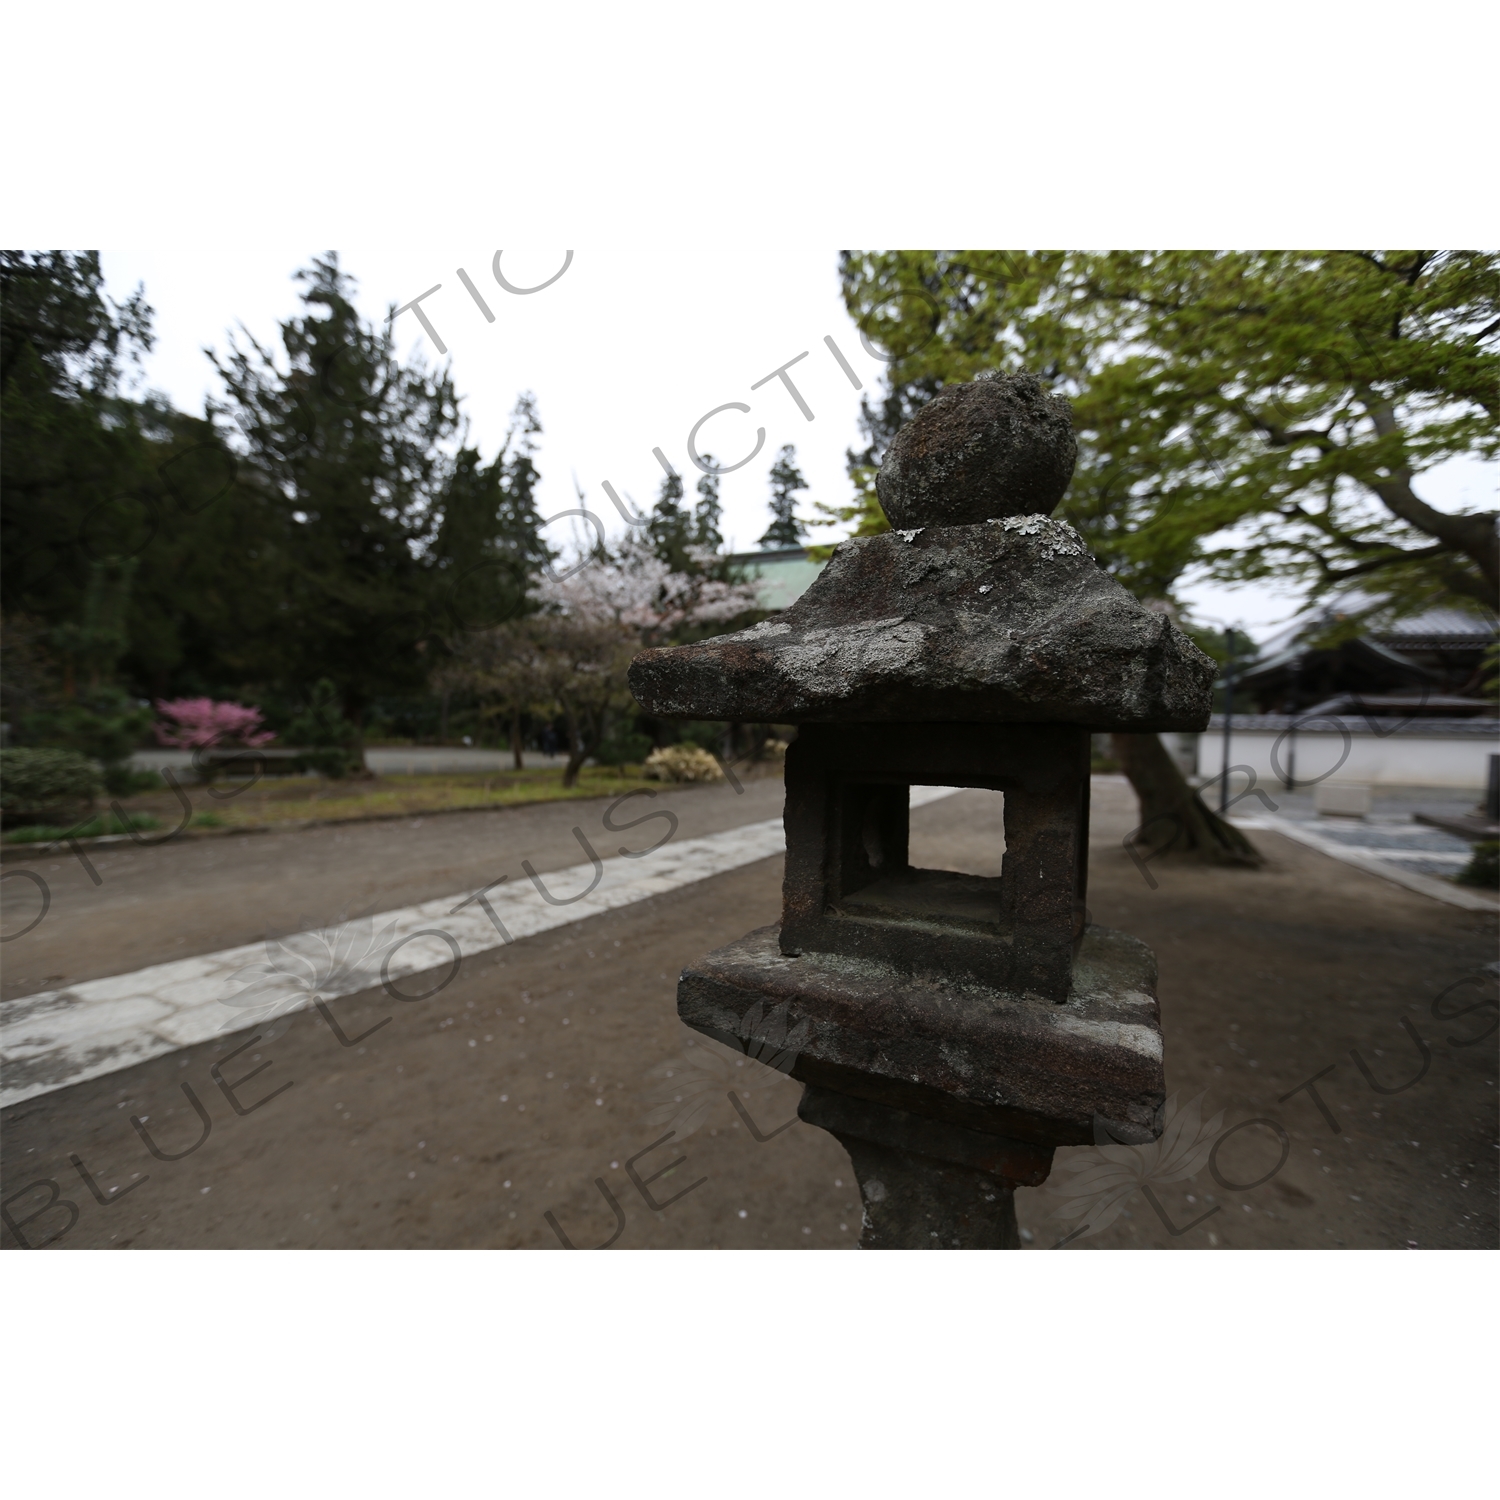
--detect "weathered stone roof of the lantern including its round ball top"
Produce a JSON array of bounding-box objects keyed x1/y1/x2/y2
[{"x1": 630, "y1": 375, "x2": 1215, "y2": 731}]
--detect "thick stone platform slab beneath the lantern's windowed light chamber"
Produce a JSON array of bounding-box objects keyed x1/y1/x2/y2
[{"x1": 677, "y1": 926, "x2": 1166, "y2": 1146}]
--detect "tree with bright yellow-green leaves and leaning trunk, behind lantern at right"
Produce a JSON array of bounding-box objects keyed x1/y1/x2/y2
[{"x1": 842, "y1": 251, "x2": 1500, "y2": 860}]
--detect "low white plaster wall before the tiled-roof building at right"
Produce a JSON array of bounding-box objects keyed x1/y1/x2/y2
[{"x1": 1199, "y1": 729, "x2": 1500, "y2": 792}]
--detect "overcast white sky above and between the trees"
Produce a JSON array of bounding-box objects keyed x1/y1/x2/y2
[{"x1": 104, "y1": 245, "x2": 1496, "y2": 639}]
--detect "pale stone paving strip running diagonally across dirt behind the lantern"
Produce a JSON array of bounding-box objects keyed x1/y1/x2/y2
[{"x1": 0, "y1": 786, "x2": 957, "y2": 1107}]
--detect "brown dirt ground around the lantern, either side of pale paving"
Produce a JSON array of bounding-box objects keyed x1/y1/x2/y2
[{"x1": 0, "y1": 779, "x2": 1500, "y2": 1250}]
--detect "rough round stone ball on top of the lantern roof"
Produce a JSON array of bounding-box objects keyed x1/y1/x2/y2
[{"x1": 876, "y1": 372, "x2": 1079, "y2": 531}]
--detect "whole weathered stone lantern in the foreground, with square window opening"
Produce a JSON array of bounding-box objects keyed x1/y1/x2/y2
[{"x1": 630, "y1": 375, "x2": 1214, "y2": 1250}]
